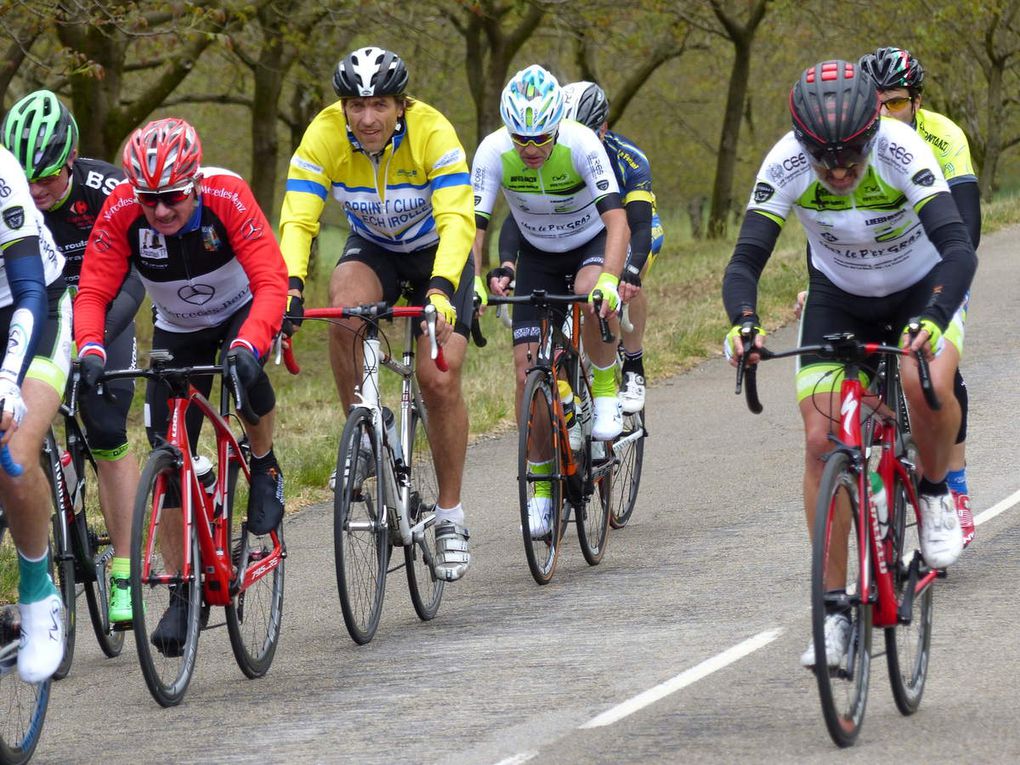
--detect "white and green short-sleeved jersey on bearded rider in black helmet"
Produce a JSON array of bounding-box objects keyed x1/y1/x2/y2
[{"x1": 748, "y1": 117, "x2": 949, "y2": 298}]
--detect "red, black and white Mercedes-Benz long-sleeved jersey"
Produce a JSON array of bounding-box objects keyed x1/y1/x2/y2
[{"x1": 74, "y1": 167, "x2": 288, "y2": 357}]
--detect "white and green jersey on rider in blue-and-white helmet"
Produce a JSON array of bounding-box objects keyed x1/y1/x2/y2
[{"x1": 471, "y1": 119, "x2": 619, "y2": 252}]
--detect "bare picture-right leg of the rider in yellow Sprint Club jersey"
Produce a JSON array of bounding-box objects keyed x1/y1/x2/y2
[{"x1": 415, "y1": 334, "x2": 468, "y2": 508}]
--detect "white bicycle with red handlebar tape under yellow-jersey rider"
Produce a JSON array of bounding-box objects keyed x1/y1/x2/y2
[{"x1": 304, "y1": 302, "x2": 447, "y2": 645}]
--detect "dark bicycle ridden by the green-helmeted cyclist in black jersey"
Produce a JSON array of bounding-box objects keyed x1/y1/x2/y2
[{"x1": 42, "y1": 361, "x2": 124, "y2": 680}]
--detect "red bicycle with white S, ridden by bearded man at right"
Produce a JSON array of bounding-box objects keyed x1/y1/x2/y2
[{"x1": 737, "y1": 324, "x2": 945, "y2": 747}]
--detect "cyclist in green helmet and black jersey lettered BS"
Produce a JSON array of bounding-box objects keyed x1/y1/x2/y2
[{"x1": 0, "y1": 91, "x2": 145, "y2": 622}]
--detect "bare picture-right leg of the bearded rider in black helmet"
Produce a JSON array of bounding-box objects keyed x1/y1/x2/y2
[{"x1": 901, "y1": 343, "x2": 960, "y2": 483}]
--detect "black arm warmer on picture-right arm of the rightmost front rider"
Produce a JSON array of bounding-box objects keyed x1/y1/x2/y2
[{"x1": 918, "y1": 193, "x2": 977, "y2": 330}]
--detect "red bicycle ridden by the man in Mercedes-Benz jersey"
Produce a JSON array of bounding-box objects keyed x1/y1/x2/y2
[{"x1": 101, "y1": 350, "x2": 287, "y2": 707}]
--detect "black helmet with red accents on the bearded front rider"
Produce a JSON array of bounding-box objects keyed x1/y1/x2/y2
[{"x1": 789, "y1": 61, "x2": 880, "y2": 168}]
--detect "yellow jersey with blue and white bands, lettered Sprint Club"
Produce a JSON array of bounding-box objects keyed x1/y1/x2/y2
[{"x1": 279, "y1": 101, "x2": 474, "y2": 291}]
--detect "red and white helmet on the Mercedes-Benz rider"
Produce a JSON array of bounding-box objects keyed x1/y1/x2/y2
[{"x1": 122, "y1": 117, "x2": 202, "y2": 192}]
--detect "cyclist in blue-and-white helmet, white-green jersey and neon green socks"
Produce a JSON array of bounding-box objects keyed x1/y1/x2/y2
[{"x1": 471, "y1": 65, "x2": 630, "y2": 538}]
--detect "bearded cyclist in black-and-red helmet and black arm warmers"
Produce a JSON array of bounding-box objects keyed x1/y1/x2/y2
[{"x1": 723, "y1": 61, "x2": 977, "y2": 666}]
